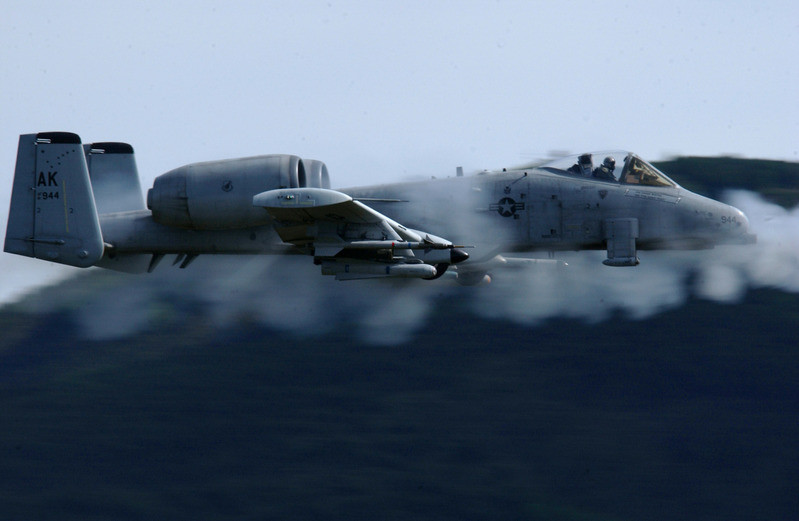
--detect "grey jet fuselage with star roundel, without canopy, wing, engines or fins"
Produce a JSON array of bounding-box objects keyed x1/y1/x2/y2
[{"x1": 100, "y1": 159, "x2": 748, "y2": 262}]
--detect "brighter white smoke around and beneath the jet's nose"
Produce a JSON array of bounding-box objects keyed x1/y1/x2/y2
[{"x1": 472, "y1": 191, "x2": 799, "y2": 323}]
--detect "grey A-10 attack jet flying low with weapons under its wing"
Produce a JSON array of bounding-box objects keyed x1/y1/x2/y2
[{"x1": 5, "y1": 132, "x2": 754, "y2": 284}]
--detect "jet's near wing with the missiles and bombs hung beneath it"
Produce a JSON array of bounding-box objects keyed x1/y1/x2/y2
[{"x1": 253, "y1": 188, "x2": 468, "y2": 280}]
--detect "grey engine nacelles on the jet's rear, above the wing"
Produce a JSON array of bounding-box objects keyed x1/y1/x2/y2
[{"x1": 147, "y1": 155, "x2": 330, "y2": 230}]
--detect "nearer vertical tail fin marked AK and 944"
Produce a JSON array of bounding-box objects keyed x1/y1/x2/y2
[{"x1": 4, "y1": 132, "x2": 104, "y2": 268}]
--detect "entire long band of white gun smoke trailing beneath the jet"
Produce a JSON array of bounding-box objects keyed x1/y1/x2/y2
[{"x1": 6, "y1": 191, "x2": 799, "y2": 345}]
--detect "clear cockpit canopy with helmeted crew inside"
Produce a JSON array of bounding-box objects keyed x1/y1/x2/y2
[{"x1": 538, "y1": 150, "x2": 677, "y2": 187}]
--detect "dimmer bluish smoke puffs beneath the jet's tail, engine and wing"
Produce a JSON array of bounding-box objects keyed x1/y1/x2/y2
[{"x1": 53, "y1": 256, "x2": 444, "y2": 345}]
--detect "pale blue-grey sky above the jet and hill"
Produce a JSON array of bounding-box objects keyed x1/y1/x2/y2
[{"x1": 0, "y1": 0, "x2": 799, "y2": 296}]
